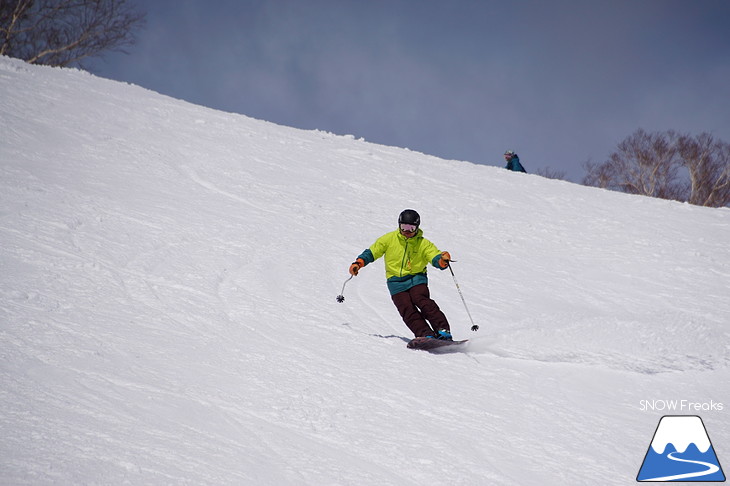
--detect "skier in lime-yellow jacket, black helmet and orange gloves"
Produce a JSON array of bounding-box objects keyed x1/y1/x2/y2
[{"x1": 350, "y1": 209, "x2": 452, "y2": 340}]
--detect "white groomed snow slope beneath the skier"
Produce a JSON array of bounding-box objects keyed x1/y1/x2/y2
[{"x1": 0, "y1": 58, "x2": 730, "y2": 486}]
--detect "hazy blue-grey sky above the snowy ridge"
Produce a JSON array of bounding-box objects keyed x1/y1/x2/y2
[{"x1": 87, "y1": 0, "x2": 730, "y2": 181}]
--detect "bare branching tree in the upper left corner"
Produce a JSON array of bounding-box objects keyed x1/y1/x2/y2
[{"x1": 0, "y1": 0, "x2": 145, "y2": 66}]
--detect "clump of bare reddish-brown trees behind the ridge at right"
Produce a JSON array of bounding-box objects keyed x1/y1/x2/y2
[{"x1": 583, "y1": 129, "x2": 730, "y2": 207}]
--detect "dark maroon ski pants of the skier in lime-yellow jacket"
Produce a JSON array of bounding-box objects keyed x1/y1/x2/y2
[{"x1": 391, "y1": 284, "x2": 451, "y2": 337}]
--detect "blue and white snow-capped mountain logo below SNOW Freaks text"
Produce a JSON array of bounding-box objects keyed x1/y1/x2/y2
[{"x1": 636, "y1": 415, "x2": 725, "y2": 482}]
